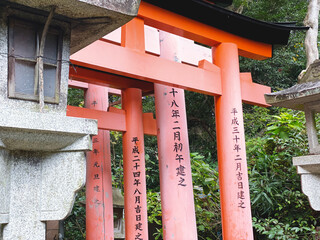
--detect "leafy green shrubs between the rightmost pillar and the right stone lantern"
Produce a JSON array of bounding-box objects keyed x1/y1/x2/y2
[{"x1": 247, "y1": 110, "x2": 319, "y2": 239}]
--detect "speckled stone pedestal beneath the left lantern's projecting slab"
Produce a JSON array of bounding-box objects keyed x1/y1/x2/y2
[{"x1": 0, "y1": 150, "x2": 85, "y2": 240}]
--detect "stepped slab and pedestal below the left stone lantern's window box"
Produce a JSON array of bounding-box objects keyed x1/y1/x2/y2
[{"x1": 0, "y1": 110, "x2": 97, "y2": 240}]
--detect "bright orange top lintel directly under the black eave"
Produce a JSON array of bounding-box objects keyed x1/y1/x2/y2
[{"x1": 138, "y1": 1, "x2": 272, "y2": 60}]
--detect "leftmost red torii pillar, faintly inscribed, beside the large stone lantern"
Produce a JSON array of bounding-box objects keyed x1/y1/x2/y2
[{"x1": 85, "y1": 84, "x2": 114, "y2": 240}]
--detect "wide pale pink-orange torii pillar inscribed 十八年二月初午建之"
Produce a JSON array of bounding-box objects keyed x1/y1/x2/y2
[{"x1": 154, "y1": 31, "x2": 198, "y2": 240}]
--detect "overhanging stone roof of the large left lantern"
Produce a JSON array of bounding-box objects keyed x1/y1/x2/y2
[{"x1": 2, "y1": 0, "x2": 140, "y2": 54}]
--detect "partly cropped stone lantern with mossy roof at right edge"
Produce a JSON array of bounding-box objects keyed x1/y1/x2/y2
[{"x1": 265, "y1": 60, "x2": 320, "y2": 211}]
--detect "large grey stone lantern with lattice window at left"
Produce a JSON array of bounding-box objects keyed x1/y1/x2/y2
[{"x1": 0, "y1": 0, "x2": 140, "y2": 240}]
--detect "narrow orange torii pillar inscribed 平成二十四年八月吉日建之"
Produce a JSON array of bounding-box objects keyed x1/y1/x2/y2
[{"x1": 122, "y1": 88, "x2": 148, "y2": 240}]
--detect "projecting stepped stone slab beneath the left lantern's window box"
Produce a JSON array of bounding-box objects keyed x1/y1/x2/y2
[{"x1": 0, "y1": 110, "x2": 97, "y2": 151}]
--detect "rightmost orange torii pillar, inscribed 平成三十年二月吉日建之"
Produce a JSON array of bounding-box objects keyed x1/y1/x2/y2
[{"x1": 213, "y1": 43, "x2": 253, "y2": 240}]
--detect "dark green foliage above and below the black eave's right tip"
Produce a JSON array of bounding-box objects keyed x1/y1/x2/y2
[{"x1": 236, "y1": 0, "x2": 308, "y2": 90}]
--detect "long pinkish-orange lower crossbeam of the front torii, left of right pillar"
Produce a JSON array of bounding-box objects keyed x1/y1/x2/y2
[{"x1": 70, "y1": 41, "x2": 221, "y2": 95}]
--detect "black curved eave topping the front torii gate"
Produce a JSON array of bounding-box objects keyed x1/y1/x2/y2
[{"x1": 144, "y1": 0, "x2": 308, "y2": 45}]
